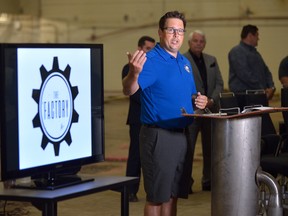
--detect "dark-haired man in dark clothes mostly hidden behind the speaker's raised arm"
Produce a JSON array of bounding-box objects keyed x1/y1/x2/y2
[{"x1": 122, "y1": 36, "x2": 155, "y2": 202}]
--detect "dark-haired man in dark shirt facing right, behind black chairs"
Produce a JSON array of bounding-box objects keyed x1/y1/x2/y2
[{"x1": 228, "y1": 25, "x2": 275, "y2": 100}]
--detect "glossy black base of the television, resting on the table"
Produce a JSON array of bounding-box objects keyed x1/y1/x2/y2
[{"x1": 14, "y1": 175, "x2": 94, "y2": 190}]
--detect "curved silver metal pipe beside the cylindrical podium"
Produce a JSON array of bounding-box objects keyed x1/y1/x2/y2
[{"x1": 256, "y1": 167, "x2": 283, "y2": 216}]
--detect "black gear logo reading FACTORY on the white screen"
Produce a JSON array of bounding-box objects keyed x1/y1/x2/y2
[{"x1": 32, "y1": 57, "x2": 79, "y2": 156}]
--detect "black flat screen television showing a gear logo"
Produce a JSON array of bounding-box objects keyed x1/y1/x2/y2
[{"x1": 0, "y1": 43, "x2": 105, "y2": 189}]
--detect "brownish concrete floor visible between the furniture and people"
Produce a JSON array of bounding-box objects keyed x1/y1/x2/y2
[{"x1": 1, "y1": 93, "x2": 282, "y2": 216}]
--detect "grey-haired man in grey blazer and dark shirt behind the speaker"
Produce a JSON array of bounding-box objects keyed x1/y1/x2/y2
[{"x1": 184, "y1": 30, "x2": 223, "y2": 193}]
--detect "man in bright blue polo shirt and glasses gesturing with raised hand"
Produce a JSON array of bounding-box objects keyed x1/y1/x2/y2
[{"x1": 123, "y1": 11, "x2": 207, "y2": 216}]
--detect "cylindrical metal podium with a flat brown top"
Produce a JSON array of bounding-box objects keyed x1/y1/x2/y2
[{"x1": 183, "y1": 107, "x2": 288, "y2": 216}]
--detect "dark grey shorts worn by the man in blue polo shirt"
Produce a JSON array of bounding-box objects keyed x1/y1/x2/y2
[{"x1": 140, "y1": 126, "x2": 192, "y2": 203}]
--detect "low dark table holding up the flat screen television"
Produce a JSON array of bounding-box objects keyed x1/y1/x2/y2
[{"x1": 0, "y1": 176, "x2": 138, "y2": 216}]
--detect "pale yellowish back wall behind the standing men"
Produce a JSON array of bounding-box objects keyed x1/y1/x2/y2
[{"x1": 0, "y1": 0, "x2": 288, "y2": 93}]
